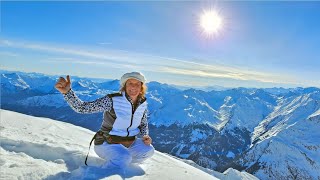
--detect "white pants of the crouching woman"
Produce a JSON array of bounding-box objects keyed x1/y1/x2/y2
[{"x1": 94, "y1": 138, "x2": 154, "y2": 168}]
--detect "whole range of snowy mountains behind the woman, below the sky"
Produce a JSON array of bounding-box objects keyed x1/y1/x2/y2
[{"x1": 1, "y1": 71, "x2": 320, "y2": 179}]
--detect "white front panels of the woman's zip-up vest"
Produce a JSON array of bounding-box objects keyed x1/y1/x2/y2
[{"x1": 109, "y1": 92, "x2": 147, "y2": 137}]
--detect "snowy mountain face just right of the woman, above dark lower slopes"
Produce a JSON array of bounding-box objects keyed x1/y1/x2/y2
[{"x1": 149, "y1": 91, "x2": 221, "y2": 129}]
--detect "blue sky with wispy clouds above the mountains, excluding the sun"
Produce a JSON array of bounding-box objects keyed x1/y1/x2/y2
[{"x1": 0, "y1": 1, "x2": 320, "y2": 87}]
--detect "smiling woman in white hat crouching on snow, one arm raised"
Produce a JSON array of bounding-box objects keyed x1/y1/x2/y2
[{"x1": 55, "y1": 72, "x2": 154, "y2": 168}]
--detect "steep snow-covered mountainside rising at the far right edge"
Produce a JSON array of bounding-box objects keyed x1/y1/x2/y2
[{"x1": 232, "y1": 91, "x2": 320, "y2": 179}]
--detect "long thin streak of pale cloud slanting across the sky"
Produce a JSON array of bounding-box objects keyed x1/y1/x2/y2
[{"x1": 0, "y1": 40, "x2": 297, "y2": 84}]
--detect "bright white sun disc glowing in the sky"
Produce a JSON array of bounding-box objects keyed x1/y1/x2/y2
[{"x1": 200, "y1": 10, "x2": 223, "y2": 36}]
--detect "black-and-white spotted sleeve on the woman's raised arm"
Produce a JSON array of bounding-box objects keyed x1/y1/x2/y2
[{"x1": 63, "y1": 90, "x2": 112, "y2": 114}]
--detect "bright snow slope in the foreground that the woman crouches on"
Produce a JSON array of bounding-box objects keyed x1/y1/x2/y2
[{"x1": 0, "y1": 110, "x2": 257, "y2": 180}]
